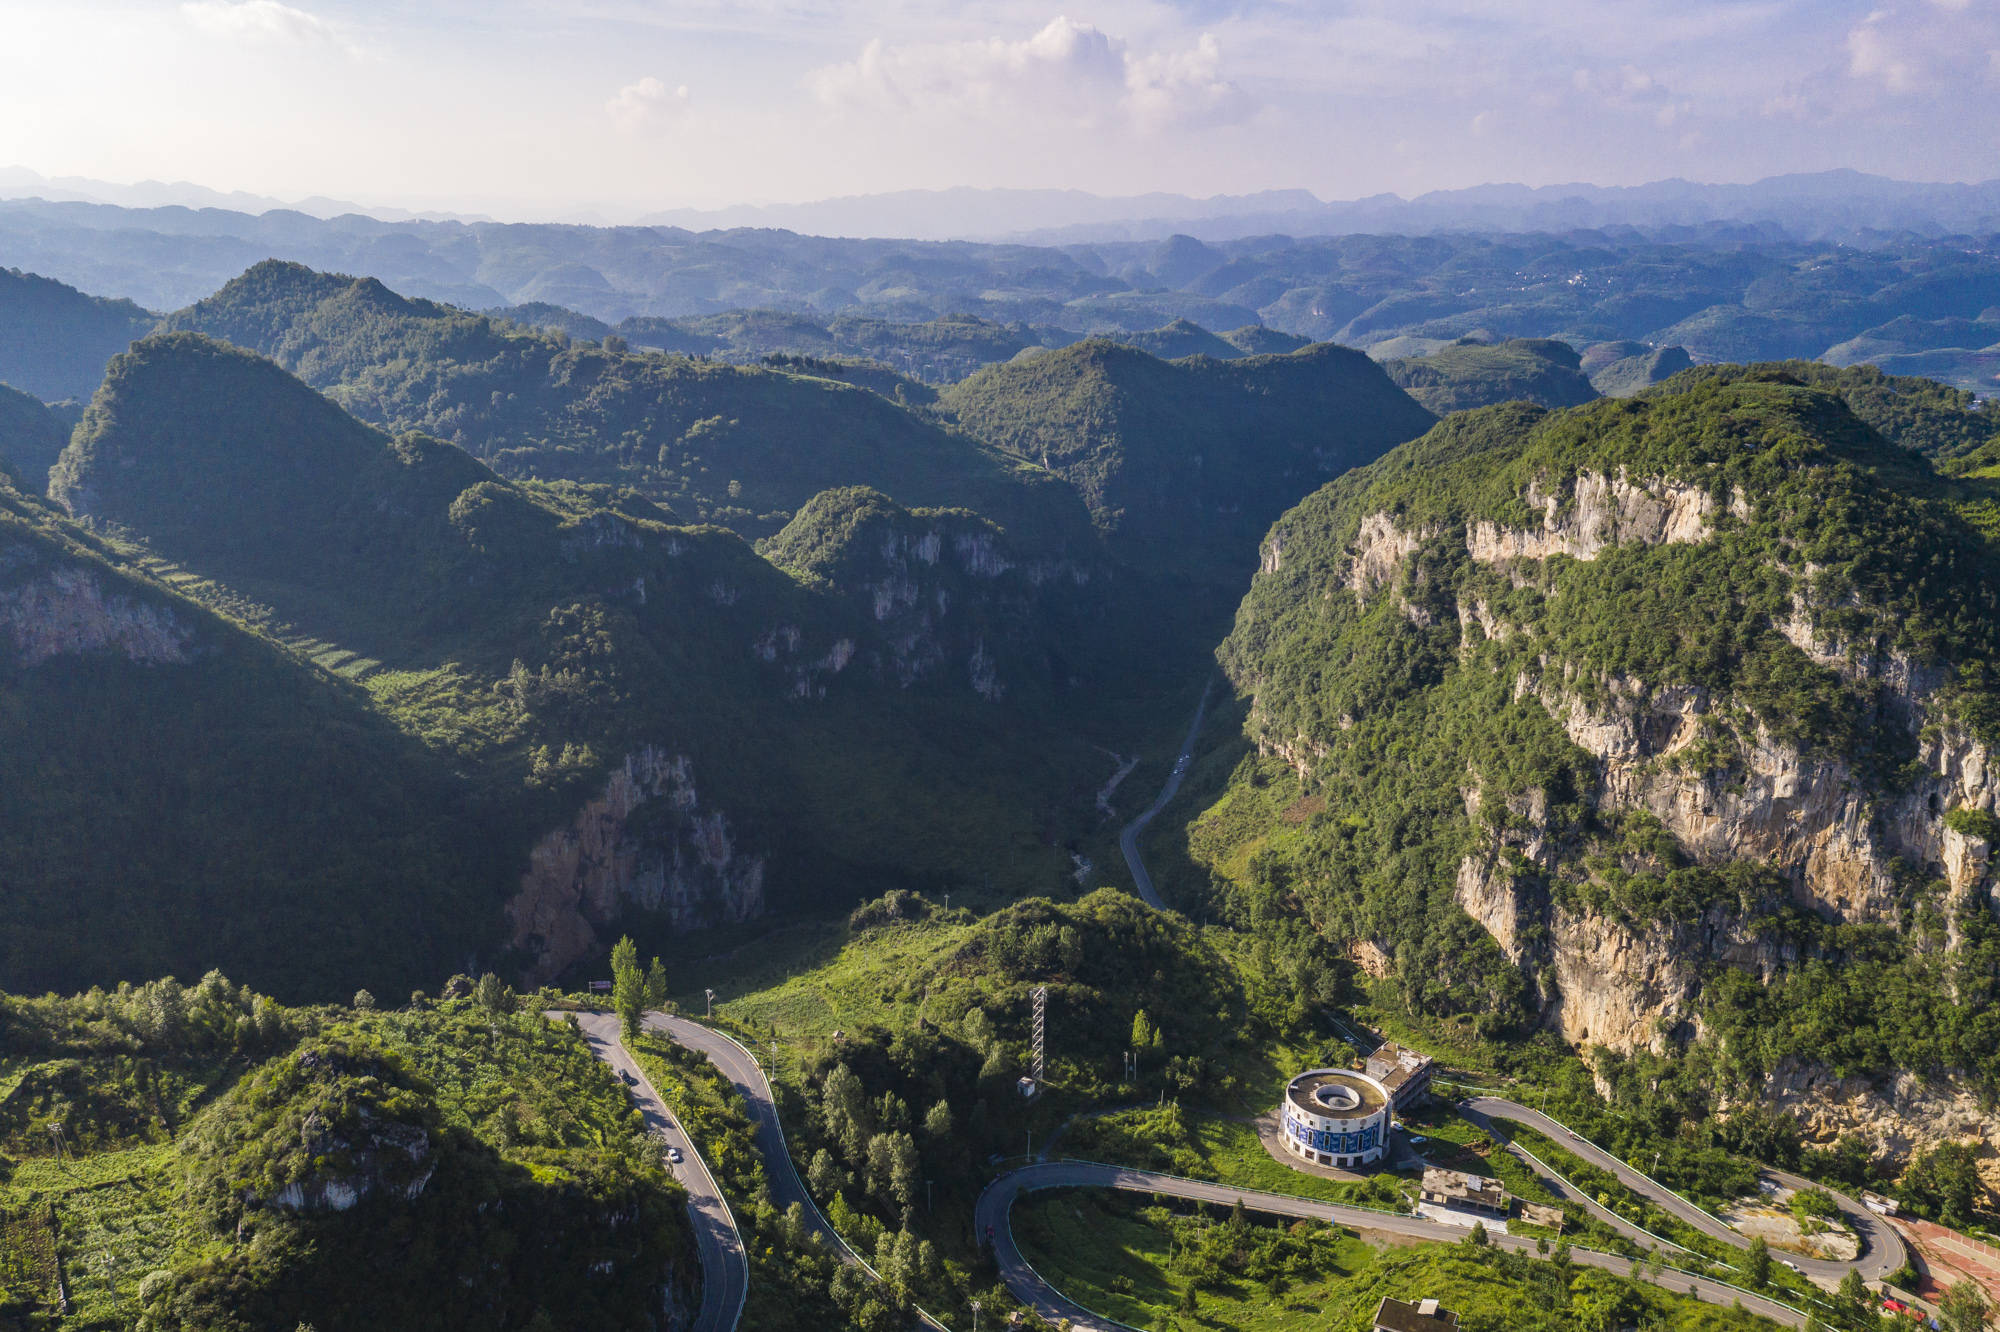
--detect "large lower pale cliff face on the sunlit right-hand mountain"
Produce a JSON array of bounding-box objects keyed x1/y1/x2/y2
[{"x1": 1458, "y1": 652, "x2": 2000, "y2": 1050}]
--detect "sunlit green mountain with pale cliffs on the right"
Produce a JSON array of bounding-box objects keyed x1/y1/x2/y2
[{"x1": 1186, "y1": 366, "x2": 2000, "y2": 1132}]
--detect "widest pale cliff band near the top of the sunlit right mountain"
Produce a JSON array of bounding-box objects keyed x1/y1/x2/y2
[{"x1": 1466, "y1": 472, "x2": 1742, "y2": 562}]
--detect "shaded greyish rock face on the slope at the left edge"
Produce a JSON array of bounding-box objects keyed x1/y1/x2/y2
[{"x1": 0, "y1": 552, "x2": 194, "y2": 666}]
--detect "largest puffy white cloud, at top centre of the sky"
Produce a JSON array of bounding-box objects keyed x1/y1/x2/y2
[{"x1": 806, "y1": 18, "x2": 1256, "y2": 130}]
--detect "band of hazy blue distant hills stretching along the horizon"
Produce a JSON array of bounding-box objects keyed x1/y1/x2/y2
[{"x1": 0, "y1": 193, "x2": 2000, "y2": 388}]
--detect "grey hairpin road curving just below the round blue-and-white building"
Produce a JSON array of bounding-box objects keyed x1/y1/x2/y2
[{"x1": 974, "y1": 1160, "x2": 1806, "y2": 1332}]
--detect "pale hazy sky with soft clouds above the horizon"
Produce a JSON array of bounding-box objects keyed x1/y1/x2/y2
[{"x1": 0, "y1": 0, "x2": 2000, "y2": 218}]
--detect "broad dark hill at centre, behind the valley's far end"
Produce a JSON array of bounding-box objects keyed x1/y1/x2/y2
[{"x1": 940, "y1": 340, "x2": 1434, "y2": 582}]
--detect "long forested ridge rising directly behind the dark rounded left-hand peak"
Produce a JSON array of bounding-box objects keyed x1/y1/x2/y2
[{"x1": 166, "y1": 262, "x2": 1086, "y2": 544}]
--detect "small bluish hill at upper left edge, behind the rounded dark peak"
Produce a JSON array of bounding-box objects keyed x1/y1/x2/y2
[{"x1": 0, "y1": 268, "x2": 156, "y2": 402}]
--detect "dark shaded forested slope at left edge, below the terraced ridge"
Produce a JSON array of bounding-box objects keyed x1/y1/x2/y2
[{"x1": 0, "y1": 452, "x2": 504, "y2": 994}]
